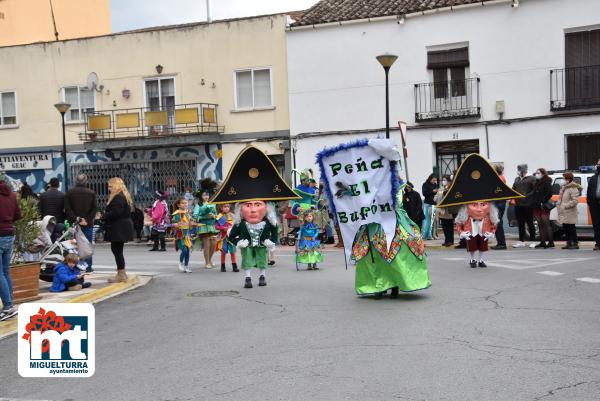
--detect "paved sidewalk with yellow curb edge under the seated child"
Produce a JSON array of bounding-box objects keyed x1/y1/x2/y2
[{"x1": 0, "y1": 273, "x2": 152, "y2": 339}]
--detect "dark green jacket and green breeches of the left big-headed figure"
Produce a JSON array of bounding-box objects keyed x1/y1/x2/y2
[{"x1": 228, "y1": 218, "x2": 279, "y2": 270}]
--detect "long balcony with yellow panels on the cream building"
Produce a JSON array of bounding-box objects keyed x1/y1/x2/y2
[{"x1": 79, "y1": 103, "x2": 224, "y2": 143}]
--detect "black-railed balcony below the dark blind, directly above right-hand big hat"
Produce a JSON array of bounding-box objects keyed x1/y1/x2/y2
[{"x1": 415, "y1": 78, "x2": 481, "y2": 122}]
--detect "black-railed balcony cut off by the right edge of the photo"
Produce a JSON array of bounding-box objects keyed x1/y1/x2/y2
[{"x1": 550, "y1": 65, "x2": 600, "y2": 111}]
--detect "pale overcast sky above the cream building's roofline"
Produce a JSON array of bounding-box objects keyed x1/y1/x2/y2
[{"x1": 110, "y1": 0, "x2": 318, "y2": 32}]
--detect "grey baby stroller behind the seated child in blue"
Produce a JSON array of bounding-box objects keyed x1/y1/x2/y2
[{"x1": 38, "y1": 216, "x2": 92, "y2": 283}]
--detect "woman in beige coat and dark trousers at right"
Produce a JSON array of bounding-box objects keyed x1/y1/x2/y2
[{"x1": 556, "y1": 171, "x2": 581, "y2": 249}]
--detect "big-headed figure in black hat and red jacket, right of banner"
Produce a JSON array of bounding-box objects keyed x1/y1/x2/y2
[{"x1": 439, "y1": 153, "x2": 523, "y2": 267}]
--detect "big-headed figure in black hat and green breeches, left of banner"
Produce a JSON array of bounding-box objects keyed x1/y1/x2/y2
[{"x1": 212, "y1": 146, "x2": 298, "y2": 288}]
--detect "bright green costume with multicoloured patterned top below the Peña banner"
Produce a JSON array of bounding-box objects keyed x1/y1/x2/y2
[{"x1": 352, "y1": 191, "x2": 431, "y2": 296}]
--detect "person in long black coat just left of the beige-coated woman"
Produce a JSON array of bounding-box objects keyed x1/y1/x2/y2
[{"x1": 533, "y1": 168, "x2": 554, "y2": 249}]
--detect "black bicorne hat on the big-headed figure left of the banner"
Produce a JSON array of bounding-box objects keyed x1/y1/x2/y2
[{"x1": 211, "y1": 146, "x2": 300, "y2": 203}]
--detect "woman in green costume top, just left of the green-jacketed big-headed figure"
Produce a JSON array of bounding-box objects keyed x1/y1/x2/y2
[{"x1": 192, "y1": 178, "x2": 219, "y2": 269}]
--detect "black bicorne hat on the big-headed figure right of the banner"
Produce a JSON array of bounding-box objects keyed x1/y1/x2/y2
[{"x1": 438, "y1": 153, "x2": 524, "y2": 207}]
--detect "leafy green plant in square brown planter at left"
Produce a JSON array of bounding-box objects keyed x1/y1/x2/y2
[{"x1": 0, "y1": 172, "x2": 40, "y2": 302}]
